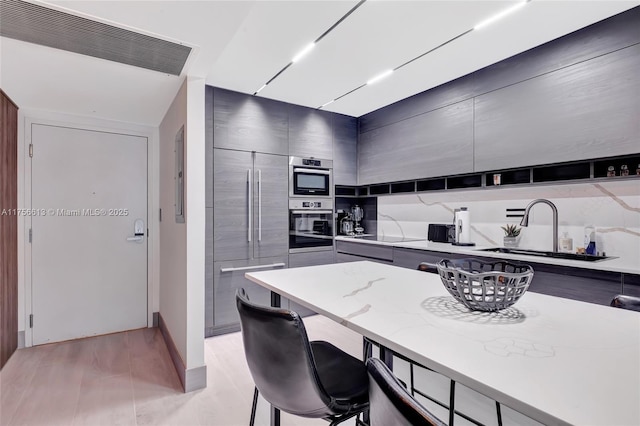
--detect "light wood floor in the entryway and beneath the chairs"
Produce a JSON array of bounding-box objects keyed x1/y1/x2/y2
[{"x1": 0, "y1": 315, "x2": 362, "y2": 426}]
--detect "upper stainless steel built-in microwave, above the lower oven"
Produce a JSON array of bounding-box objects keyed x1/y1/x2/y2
[{"x1": 289, "y1": 157, "x2": 333, "y2": 198}]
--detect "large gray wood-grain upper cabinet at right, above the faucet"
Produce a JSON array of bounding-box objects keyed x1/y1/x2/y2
[{"x1": 474, "y1": 45, "x2": 640, "y2": 171}]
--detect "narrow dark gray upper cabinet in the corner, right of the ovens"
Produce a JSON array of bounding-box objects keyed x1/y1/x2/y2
[{"x1": 333, "y1": 114, "x2": 358, "y2": 185}]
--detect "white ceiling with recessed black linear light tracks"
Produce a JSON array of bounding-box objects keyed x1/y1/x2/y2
[{"x1": 0, "y1": 0, "x2": 640, "y2": 126}]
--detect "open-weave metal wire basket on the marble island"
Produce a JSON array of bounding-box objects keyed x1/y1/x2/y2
[{"x1": 436, "y1": 259, "x2": 533, "y2": 312}]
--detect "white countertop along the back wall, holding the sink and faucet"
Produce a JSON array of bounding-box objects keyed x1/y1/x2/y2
[{"x1": 336, "y1": 236, "x2": 640, "y2": 274}]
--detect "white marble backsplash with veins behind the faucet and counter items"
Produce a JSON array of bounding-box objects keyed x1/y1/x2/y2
[{"x1": 378, "y1": 179, "x2": 640, "y2": 263}]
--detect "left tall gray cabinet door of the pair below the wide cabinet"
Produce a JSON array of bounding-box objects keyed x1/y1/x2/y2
[{"x1": 213, "y1": 149, "x2": 255, "y2": 261}]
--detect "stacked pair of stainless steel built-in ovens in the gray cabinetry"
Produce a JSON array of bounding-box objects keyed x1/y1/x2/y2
[{"x1": 289, "y1": 157, "x2": 334, "y2": 253}]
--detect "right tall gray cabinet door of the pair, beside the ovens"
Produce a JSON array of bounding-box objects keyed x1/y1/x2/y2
[{"x1": 253, "y1": 153, "x2": 289, "y2": 258}]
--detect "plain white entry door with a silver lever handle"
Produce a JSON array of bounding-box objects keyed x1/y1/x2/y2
[{"x1": 31, "y1": 124, "x2": 147, "y2": 345}]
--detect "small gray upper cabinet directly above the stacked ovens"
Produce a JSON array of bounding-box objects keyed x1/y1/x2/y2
[{"x1": 288, "y1": 105, "x2": 333, "y2": 160}]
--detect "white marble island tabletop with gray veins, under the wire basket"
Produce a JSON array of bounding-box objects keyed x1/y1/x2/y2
[{"x1": 246, "y1": 261, "x2": 640, "y2": 425}]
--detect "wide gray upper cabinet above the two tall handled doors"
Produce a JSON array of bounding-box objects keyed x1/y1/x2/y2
[{"x1": 213, "y1": 88, "x2": 289, "y2": 155}]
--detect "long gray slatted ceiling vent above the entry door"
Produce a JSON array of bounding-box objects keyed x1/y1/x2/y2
[{"x1": 0, "y1": 0, "x2": 191, "y2": 75}]
